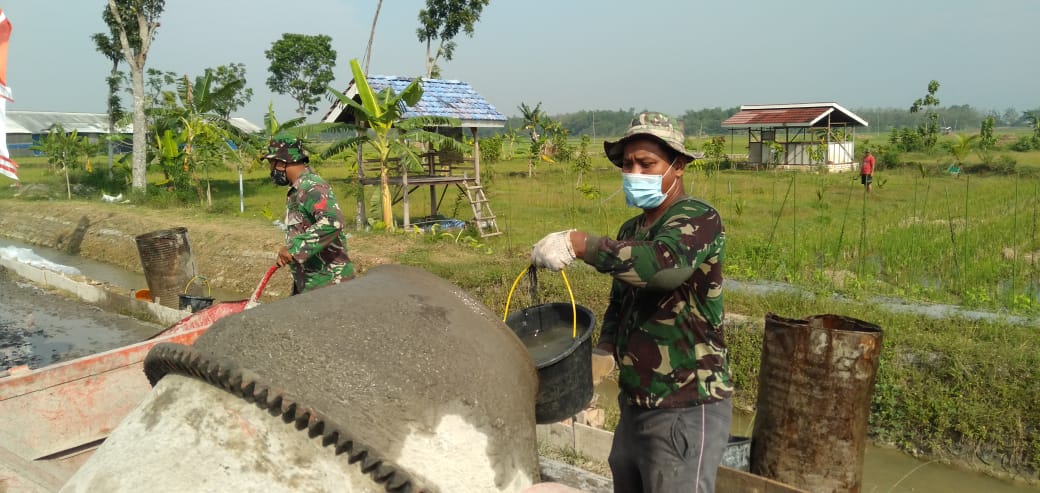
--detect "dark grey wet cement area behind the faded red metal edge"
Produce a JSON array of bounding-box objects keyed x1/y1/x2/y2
[{"x1": 0, "y1": 268, "x2": 161, "y2": 371}]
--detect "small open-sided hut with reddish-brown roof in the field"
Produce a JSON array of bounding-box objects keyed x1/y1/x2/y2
[{"x1": 722, "y1": 103, "x2": 867, "y2": 172}]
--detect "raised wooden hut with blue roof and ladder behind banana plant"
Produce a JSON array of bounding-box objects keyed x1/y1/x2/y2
[{"x1": 321, "y1": 75, "x2": 506, "y2": 236}]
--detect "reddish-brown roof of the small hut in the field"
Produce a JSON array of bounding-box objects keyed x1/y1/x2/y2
[{"x1": 722, "y1": 103, "x2": 867, "y2": 128}]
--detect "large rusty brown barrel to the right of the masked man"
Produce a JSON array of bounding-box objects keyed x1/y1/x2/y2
[{"x1": 751, "y1": 313, "x2": 882, "y2": 492}]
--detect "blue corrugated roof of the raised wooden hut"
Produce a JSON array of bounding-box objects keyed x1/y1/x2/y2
[{"x1": 321, "y1": 75, "x2": 506, "y2": 127}]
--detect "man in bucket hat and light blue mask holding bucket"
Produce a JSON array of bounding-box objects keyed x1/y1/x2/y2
[{"x1": 531, "y1": 112, "x2": 733, "y2": 493}]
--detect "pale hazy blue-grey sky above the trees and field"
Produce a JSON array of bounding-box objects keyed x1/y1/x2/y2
[{"x1": 0, "y1": 0, "x2": 1040, "y2": 124}]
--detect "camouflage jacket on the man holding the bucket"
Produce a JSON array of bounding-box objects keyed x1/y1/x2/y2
[{"x1": 584, "y1": 198, "x2": 733, "y2": 408}]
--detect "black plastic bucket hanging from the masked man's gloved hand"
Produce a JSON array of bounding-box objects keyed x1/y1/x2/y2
[{"x1": 505, "y1": 303, "x2": 596, "y2": 424}]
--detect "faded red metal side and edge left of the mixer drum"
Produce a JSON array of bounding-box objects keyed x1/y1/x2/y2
[{"x1": 0, "y1": 266, "x2": 278, "y2": 491}]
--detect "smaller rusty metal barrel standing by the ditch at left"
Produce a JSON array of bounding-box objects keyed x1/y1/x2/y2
[{"x1": 134, "y1": 228, "x2": 198, "y2": 309}]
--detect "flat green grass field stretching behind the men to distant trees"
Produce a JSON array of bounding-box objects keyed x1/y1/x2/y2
[{"x1": 6, "y1": 128, "x2": 1040, "y2": 314}]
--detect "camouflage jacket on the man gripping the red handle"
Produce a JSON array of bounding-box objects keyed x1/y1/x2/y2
[{"x1": 285, "y1": 167, "x2": 354, "y2": 293}]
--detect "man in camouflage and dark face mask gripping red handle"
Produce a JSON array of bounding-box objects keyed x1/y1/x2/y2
[{"x1": 264, "y1": 135, "x2": 354, "y2": 294}]
